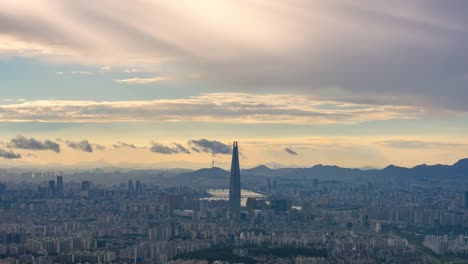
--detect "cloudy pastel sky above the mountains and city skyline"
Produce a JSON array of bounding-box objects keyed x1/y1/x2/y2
[{"x1": 0, "y1": 0, "x2": 468, "y2": 168}]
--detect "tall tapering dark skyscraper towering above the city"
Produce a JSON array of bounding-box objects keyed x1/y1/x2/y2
[{"x1": 229, "y1": 141, "x2": 241, "y2": 221}]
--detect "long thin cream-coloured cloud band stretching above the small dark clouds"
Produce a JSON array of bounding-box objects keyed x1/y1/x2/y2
[{"x1": 0, "y1": 93, "x2": 425, "y2": 125}]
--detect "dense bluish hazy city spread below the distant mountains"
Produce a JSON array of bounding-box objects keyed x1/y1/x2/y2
[{"x1": 0, "y1": 142, "x2": 468, "y2": 264}]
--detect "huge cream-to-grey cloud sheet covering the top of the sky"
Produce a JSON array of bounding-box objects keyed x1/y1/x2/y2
[{"x1": 0, "y1": 0, "x2": 468, "y2": 111}]
